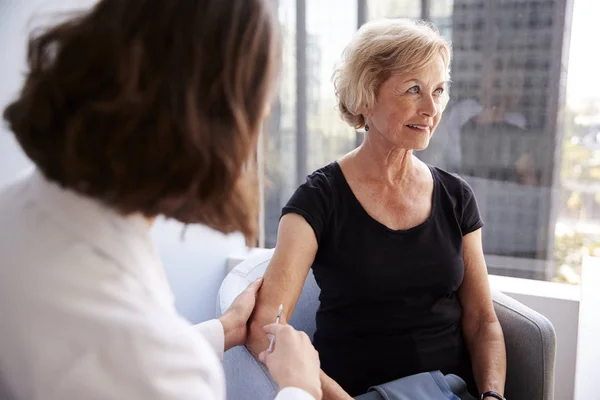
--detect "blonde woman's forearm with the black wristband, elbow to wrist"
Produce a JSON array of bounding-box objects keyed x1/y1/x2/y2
[{"x1": 465, "y1": 320, "x2": 506, "y2": 394}]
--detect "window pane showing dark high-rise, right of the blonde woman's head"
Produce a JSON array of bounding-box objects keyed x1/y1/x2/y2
[{"x1": 420, "y1": 0, "x2": 576, "y2": 279}]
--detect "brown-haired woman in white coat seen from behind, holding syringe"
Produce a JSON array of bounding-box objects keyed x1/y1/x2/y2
[{"x1": 0, "y1": 0, "x2": 321, "y2": 400}]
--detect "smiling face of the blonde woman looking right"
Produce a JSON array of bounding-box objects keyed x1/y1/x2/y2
[{"x1": 365, "y1": 56, "x2": 449, "y2": 150}]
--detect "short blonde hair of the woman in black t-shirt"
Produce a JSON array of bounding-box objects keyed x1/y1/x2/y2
[{"x1": 333, "y1": 19, "x2": 452, "y2": 129}]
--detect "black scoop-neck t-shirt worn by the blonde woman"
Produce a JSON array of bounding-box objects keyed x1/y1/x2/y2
[{"x1": 282, "y1": 162, "x2": 483, "y2": 396}]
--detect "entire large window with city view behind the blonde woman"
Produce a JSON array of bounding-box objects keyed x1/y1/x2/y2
[{"x1": 264, "y1": 0, "x2": 600, "y2": 283}]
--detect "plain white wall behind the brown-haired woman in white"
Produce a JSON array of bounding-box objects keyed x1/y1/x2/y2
[{"x1": 0, "y1": 0, "x2": 244, "y2": 322}]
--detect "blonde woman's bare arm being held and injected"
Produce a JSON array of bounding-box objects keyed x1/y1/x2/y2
[{"x1": 246, "y1": 214, "x2": 352, "y2": 400}]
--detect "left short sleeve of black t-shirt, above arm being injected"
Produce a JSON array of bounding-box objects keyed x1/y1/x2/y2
[{"x1": 281, "y1": 170, "x2": 333, "y2": 244}]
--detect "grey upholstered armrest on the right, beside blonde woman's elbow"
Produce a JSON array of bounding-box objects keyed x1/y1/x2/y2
[{"x1": 492, "y1": 290, "x2": 556, "y2": 400}]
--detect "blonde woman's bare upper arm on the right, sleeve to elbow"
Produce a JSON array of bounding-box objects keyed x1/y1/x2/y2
[{"x1": 458, "y1": 229, "x2": 497, "y2": 335}]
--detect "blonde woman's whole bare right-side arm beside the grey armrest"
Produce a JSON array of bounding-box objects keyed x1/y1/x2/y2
[{"x1": 458, "y1": 229, "x2": 506, "y2": 394}]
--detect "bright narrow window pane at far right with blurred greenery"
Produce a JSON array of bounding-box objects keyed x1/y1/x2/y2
[{"x1": 554, "y1": 0, "x2": 600, "y2": 283}]
